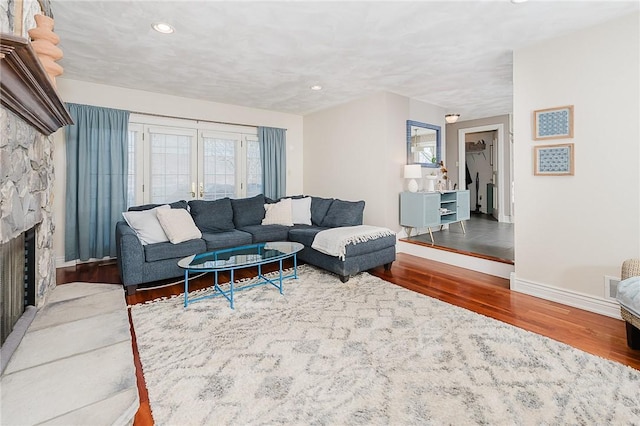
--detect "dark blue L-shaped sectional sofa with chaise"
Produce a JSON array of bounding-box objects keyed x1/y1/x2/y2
[{"x1": 115, "y1": 194, "x2": 396, "y2": 294}]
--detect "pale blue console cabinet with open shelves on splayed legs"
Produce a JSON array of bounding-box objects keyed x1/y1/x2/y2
[{"x1": 400, "y1": 190, "x2": 471, "y2": 243}]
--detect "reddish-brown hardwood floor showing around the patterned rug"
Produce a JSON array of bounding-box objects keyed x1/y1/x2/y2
[{"x1": 57, "y1": 253, "x2": 640, "y2": 426}]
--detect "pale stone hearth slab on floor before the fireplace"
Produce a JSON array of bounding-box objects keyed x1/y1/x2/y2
[{"x1": 0, "y1": 283, "x2": 139, "y2": 425}]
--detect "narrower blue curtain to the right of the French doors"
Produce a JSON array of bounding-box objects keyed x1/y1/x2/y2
[{"x1": 258, "y1": 127, "x2": 287, "y2": 200}]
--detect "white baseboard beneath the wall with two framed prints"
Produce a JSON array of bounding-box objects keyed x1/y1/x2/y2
[{"x1": 510, "y1": 272, "x2": 622, "y2": 319}]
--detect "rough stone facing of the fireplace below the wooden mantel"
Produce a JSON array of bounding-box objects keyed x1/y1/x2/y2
[{"x1": 0, "y1": 107, "x2": 56, "y2": 340}]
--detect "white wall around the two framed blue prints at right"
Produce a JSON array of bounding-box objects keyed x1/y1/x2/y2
[{"x1": 512, "y1": 14, "x2": 640, "y2": 312}]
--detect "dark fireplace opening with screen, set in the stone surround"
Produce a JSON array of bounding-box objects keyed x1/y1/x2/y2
[{"x1": 0, "y1": 227, "x2": 36, "y2": 344}]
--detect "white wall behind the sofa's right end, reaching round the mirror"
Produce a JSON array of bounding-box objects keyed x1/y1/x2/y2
[{"x1": 304, "y1": 92, "x2": 444, "y2": 231}]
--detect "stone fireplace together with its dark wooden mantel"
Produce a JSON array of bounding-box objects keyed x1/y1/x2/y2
[{"x1": 0, "y1": 33, "x2": 73, "y2": 342}]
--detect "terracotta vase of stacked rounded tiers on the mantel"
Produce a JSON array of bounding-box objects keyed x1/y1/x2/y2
[{"x1": 29, "y1": 15, "x2": 63, "y2": 87}]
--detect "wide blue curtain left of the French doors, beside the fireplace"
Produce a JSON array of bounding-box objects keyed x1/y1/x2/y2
[{"x1": 65, "y1": 103, "x2": 129, "y2": 261}]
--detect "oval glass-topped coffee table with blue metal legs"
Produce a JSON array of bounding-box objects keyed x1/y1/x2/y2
[{"x1": 178, "y1": 241, "x2": 304, "y2": 309}]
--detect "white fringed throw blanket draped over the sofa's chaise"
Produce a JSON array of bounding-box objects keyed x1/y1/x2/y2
[{"x1": 311, "y1": 225, "x2": 395, "y2": 260}]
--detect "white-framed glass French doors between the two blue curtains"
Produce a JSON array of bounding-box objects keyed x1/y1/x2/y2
[{"x1": 128, "y1": 116, "x2": 262, "y2": 205}]
